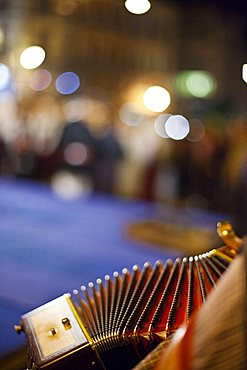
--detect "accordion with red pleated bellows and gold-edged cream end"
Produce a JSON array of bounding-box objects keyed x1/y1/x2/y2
[{"x1": 16, "y1": 222, "x2": 242, "y2": 370}]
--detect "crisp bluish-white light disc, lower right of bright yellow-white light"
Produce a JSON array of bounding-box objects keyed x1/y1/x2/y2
[{"x1": 165, "y1": 114, "x2": 190, "y2": 140}]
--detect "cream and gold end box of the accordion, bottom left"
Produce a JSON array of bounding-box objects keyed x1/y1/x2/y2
[{"x1": 20, "y1": 294, "x2": 104, "y2": 370}]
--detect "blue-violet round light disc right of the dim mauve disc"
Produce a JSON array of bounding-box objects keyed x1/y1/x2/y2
[{"x1": 55, "y1": 72, "x2": 80, "y2": 95}]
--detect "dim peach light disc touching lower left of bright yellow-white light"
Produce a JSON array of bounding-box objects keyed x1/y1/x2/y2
[{"x1": 119, "y1": 102, "x2": 145, "y2": 126}]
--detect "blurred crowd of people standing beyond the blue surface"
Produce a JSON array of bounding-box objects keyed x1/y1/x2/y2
[{"x1": 0, "y1": 94, "x2": 247, "y2": 229}]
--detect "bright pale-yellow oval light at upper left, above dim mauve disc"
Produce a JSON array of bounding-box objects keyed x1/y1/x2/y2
[{"x1": 20, "y1": 46, "x2": 45, "y2": 69}]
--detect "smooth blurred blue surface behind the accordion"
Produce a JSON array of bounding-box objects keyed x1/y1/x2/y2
[{"x1": 0, "y1": 178, "x2": 224, "y2": 356}]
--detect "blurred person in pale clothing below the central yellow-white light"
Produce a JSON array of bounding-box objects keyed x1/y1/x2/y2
[{"x1": 116, "y1": 118, "x2": 170, "y2": 199}]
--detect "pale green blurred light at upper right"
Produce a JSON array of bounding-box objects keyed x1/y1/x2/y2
[{"x1": 174, "y1": 70, "x2": 217, "y2": 98}]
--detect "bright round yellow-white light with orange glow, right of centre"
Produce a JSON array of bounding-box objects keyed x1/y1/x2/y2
[{"x1": 143, "y1": 86, "x2": 171, "y2": 112}]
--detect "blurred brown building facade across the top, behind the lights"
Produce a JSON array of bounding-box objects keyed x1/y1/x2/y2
[{"x1": 0, "y1": 0, "x2": 246, "y2": 111}]
